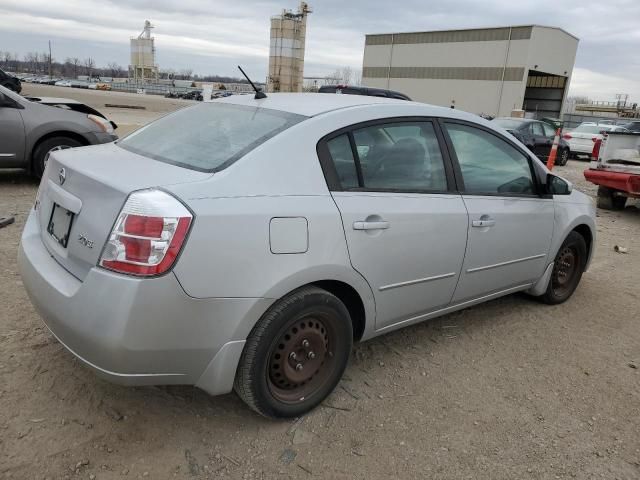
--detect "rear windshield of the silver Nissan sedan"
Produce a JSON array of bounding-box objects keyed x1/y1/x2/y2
[{"x1": 118, "y1": 102, "x2": 306, "y2": 172}]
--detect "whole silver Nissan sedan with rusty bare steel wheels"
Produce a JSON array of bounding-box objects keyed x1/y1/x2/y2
[{"x1": 19, "y1": 93, "x2": 597, "y2": 417}]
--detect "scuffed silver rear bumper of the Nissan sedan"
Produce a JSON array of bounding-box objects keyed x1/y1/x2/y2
[{"x1": 19, "y1": 212, "x2": 271, "y2": 394}]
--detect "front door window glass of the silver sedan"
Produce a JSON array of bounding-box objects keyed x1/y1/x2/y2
[{"x1": 445, "y1": 123, "x2": 535, "y2": 195}]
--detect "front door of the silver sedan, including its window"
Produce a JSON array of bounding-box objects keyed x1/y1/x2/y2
[{"x1": 443, "y1": 120, "x2": 554, "y2": 303}]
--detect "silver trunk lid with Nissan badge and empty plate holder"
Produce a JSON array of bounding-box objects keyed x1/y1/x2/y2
[{"x1": 38, "y1": 144, "x2": 211, "y2": 280}]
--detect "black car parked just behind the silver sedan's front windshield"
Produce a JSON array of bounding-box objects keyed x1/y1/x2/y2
[{"x1": 492, "y1": 117, "x2": 571, "y2": 165}]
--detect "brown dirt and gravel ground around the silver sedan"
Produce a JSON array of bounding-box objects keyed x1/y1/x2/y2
[{"x1": 0, "y1": 88, "x2": 640, "y2": 479}]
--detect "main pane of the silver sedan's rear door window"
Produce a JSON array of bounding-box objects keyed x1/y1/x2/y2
[{"x1": 353, "y1": 122, "x2": 447, "y2": 192}]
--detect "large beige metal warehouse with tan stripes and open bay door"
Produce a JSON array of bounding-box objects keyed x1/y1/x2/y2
[{"x1": 362, "y1": 25, "x2": 578, "y2": 118}]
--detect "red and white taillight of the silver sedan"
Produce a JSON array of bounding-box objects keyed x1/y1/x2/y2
[{"x1": 99, "y1": 189, "x2": 193, "y2": 276}]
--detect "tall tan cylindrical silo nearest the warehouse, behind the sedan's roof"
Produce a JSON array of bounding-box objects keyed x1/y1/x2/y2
[{"x1": 267, "y1": 2, "x2": 311, "y2": 92}]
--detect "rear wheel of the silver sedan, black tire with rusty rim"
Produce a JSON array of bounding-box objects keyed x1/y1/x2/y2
[{"x1": 234, "y1": 287, "x2": 353, "y2": 418}]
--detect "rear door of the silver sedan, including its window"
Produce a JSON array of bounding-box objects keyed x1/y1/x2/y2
[{"x1": 318, "y1": 118, "x2": 468, "y2": 329}]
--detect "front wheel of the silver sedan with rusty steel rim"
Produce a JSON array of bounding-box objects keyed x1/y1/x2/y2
[{"x1": 538, "y1": 232, "x2": 587, "y2": 305}]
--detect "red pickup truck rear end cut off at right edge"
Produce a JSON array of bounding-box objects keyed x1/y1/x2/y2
[{"x1": 584, "y1": 132, "x2": 640, "y2": 210}]
